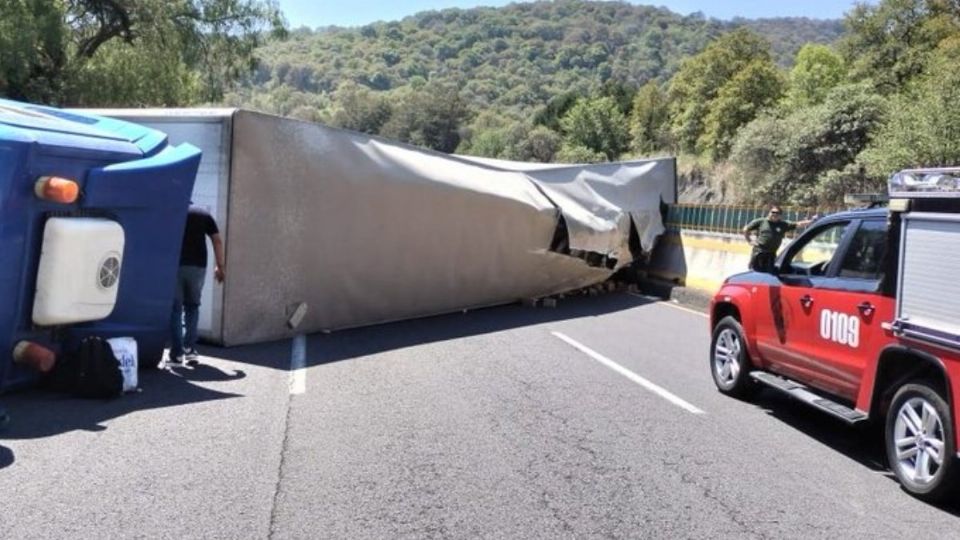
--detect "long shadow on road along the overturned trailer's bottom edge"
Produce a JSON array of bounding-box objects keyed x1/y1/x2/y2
[{"x1": 200, "y1": 293, "x2": 654, "y2": 370}]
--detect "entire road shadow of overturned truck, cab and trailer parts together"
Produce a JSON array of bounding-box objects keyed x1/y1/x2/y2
[{"x1": 0, "y1": 293, "x2": 651, "y2": 448}]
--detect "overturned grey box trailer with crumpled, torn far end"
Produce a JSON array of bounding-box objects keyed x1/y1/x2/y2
[{"x1": 80, "y1": 109, "x2": 676, "y2": 345}]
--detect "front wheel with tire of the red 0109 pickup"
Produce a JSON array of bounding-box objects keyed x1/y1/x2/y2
[{"x1": 710, "y1": 316, "x2": 756, "y2": 397}]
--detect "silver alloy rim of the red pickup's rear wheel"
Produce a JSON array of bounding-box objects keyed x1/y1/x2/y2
[{"x1": 893, "y1": 397, "x2": 945, "y2": 485}]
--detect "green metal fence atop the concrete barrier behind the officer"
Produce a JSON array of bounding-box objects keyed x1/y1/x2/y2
[{"x1": 666, "y1": 204, "x2": 839, "y2": 234}]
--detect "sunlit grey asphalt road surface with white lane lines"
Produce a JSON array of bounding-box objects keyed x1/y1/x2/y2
[{"x1": 0, "y1": 293, "x2": 960, "y2": 539}]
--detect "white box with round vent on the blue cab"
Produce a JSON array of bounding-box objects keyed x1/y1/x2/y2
[{"x1": 33, "y1": 218, "x2": 124, "y2": 326}]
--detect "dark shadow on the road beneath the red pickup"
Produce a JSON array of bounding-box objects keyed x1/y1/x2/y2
[{"x1": 750, "y1": 388, "x2": 960, "y2": 517}]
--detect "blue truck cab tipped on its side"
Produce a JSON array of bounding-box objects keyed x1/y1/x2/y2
[{"x1": 0, "y1": 100, "x2": 200, "y2": 388}]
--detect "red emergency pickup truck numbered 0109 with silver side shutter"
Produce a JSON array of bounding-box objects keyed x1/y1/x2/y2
[{"x1": 710, "y1": 169, "x2": 960, "y2": 501}]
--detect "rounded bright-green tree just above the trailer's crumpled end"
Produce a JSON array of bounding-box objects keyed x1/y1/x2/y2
[{"x1": 560, "y1": 97, "x2": 629, "y2": 161}]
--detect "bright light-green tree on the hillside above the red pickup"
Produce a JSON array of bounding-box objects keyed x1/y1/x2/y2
[{"x1": 785, "y1": 43, "x2": 846, "y2": 109}]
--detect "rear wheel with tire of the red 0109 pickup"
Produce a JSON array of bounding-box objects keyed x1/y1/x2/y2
[{"x1": 884, "y1": 381, "x2": 958, "y2": 502}]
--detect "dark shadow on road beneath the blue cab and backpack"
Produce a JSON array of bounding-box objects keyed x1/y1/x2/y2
[{"x1": 0, "y1": 364, "x2": 246, "y2": 440}]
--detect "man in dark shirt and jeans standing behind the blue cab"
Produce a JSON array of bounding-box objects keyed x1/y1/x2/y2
[{"x1": 168, "y1": 206, "x2": 227, "y2": 365}]
